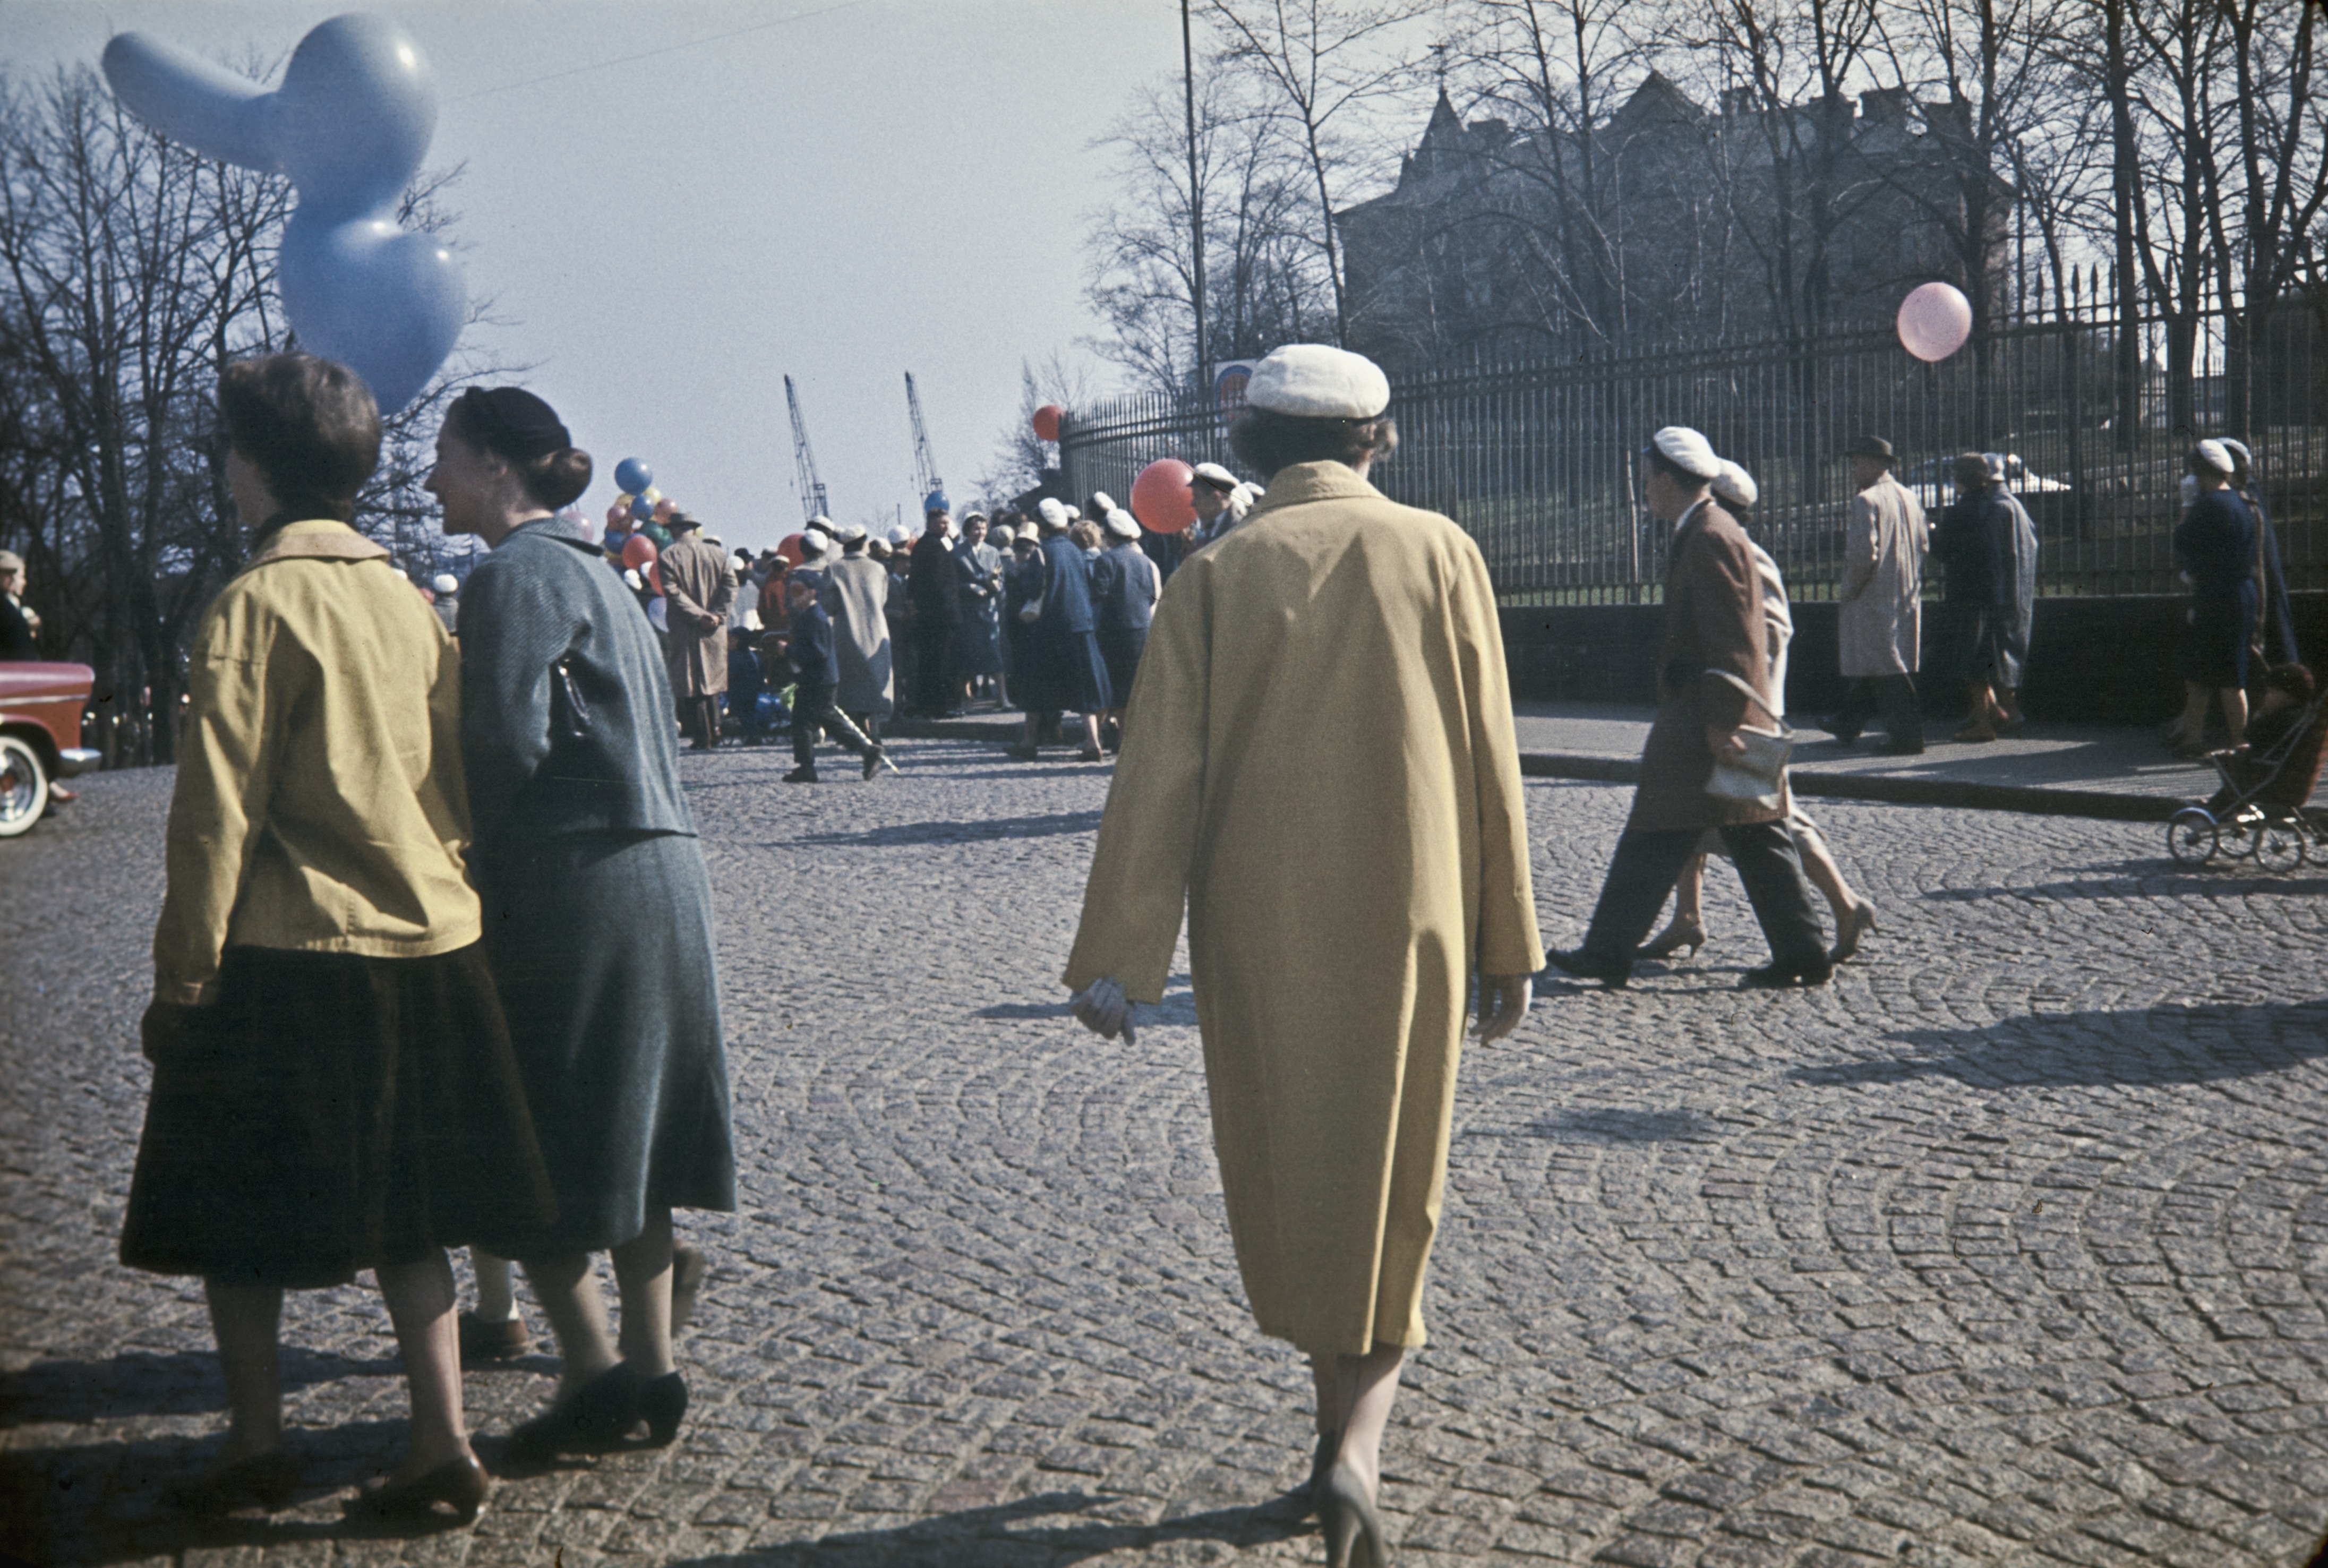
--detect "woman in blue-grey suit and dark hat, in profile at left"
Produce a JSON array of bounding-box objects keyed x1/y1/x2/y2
[{"x1": 429, "y1": 386, "x2": 735, "y2": 1463}]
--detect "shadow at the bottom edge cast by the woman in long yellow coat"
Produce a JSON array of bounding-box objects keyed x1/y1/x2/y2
[{"x1": 673, "y1": 1491, "x2": 1315, "y2": 1568}]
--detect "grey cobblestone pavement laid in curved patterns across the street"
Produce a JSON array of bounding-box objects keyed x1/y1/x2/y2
[{"x1": 0, "y1": 742, "x2": 2328, "y2": 1568}]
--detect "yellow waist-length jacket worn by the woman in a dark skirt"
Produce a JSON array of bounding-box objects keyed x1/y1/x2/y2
[{"x1": 153, "y1": 519, "x2": 482, "y2": 1005}]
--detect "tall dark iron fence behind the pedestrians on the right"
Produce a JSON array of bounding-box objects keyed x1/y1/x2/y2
[{"x1": 1059, "y1": 291, "x2": 2328, "y2": 603}]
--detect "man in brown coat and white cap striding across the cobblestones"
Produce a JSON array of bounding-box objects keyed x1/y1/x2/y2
[{"x1": 1551, "y1": 426, "x2": 1832, "y2": 989}]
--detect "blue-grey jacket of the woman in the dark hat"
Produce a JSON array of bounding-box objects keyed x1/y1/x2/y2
[{"x1": 461, "y1": 519, "x2": 696, "y2": 856}]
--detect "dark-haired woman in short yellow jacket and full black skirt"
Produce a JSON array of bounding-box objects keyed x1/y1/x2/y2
[{"x1": 121, "y1": 354, "x2": 550, "y2": 1519}]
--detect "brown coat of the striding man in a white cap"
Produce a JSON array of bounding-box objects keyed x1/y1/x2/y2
[{"x1": 1625, "y1": 500, "x2": 1793, "y2": 830}]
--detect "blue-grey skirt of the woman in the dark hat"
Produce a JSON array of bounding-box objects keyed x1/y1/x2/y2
[{"x1": 477, "y1": 833, "x2": 735, "y2": 1258}]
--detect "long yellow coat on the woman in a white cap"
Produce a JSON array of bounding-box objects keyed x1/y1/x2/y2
[{"x1": 1066, "y1": 463, "x2": 1544, "y2": 1354}]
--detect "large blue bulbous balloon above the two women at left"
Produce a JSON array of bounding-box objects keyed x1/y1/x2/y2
[{"x1": 105, "y1": 12, "x2": 468, "y2": 414}]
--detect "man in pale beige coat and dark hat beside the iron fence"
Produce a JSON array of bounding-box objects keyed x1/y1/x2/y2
[{"x1": 1818, "y1": 435, "x2": 1930, "y2": 756}]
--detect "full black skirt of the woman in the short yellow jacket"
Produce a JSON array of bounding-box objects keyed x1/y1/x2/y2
[{"x1": 121, "y1": 947, "x2": 552, "y2": 1289}]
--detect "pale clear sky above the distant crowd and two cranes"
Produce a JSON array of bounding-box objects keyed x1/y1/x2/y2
[{"x1": 0, "y1": 0, "x2": 1180, "y2": 547}]
